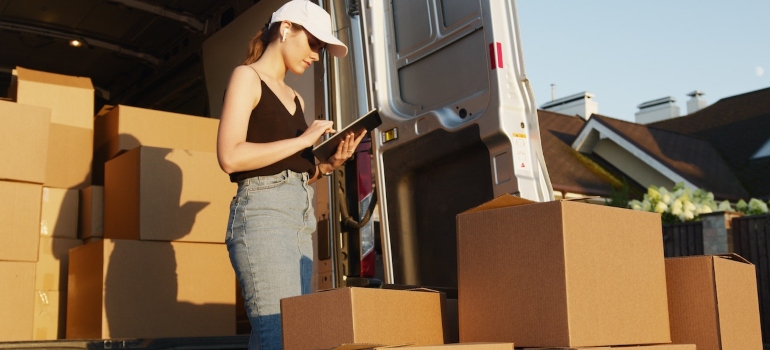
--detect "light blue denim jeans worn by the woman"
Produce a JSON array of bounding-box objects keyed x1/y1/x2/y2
[{"x1": 225, "y1": 170, "x2": 316, "y2": 350}]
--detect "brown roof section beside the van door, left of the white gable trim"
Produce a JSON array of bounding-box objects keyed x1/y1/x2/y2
[{"x1": 538, "y1": 110, "x2": 612, "y2": 197}]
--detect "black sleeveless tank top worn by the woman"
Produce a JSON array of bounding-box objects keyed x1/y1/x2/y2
[{"x1": 230, "y1": 79, "x2": 315, "y2": 182}]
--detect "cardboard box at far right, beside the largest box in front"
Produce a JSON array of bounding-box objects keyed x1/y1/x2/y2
[{"x1": 665, "y1": 254, "x2": 762, "y2": 350}]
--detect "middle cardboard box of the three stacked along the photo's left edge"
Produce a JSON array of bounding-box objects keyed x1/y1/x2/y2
[{"x1": 0, "y1": 181, "x2": 43, "y2": 262}]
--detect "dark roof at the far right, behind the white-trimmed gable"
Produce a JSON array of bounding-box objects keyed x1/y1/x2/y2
[{"x1": 648, "y1": 88, "x2": 770, "y2": 199}]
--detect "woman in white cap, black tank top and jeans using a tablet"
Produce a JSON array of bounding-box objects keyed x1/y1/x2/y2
[{"x1": 217, "y1": 0, "x2": 365, "y2": 349}]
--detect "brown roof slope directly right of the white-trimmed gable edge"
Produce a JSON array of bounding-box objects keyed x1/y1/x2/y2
[{"x1": 585, "y1": 114, "x2": 748, "y2": 200}]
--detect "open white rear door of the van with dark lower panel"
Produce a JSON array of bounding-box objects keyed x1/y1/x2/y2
[{"x1": 360, "y1": 0, "x2": 553, "y2": 288}]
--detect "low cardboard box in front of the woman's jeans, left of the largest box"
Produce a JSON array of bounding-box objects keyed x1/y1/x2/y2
[{"x1": 281, "y1": 288, "x2": 444, "y2": 350}]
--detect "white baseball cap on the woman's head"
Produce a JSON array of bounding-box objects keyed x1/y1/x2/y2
[{"x1": 270, "y1": 0, "x2": 348, "y2": 57}]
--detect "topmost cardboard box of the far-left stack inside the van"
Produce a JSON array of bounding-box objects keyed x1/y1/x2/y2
[{"x1": 8, "y1": 67, "x2": 94, "y2": 129}]
